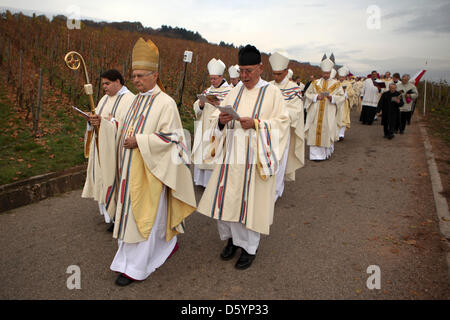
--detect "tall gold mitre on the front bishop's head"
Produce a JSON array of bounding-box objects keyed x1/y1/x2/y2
[{"x1": 131, "y1": 38, "x2": 159, "y2": 72}]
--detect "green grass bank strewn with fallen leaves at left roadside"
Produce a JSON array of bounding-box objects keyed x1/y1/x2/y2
[{"x1": 0, "y1": 88, "x2": 86, "y2": 185}]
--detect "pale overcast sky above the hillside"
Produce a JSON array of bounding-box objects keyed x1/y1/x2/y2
[{"x1": 0, "y1": 0, "x2": 450, "y2": 81}]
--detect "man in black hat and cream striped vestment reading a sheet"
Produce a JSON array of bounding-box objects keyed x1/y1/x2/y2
[{"x1": 198, "y1": 45, "x2": 289, "y2": 269}]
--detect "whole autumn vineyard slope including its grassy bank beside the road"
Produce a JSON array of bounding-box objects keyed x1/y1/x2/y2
[{"x1": 0, "y1": 11, "x2": 319, "y2": 185}]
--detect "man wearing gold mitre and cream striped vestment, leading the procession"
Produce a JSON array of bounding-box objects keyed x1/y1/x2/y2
[{"x1": 91, "y1": 38, "x2": 196, "y2": 286}]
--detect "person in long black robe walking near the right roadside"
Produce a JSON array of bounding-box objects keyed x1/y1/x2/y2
[{"x1": 377, "y1": 82, "x2": 404, "y2": 139}]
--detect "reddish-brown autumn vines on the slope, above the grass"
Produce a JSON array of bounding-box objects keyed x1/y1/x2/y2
[{"x1": 0, "y1": 12, "x2": 318, "y2": 121}]
